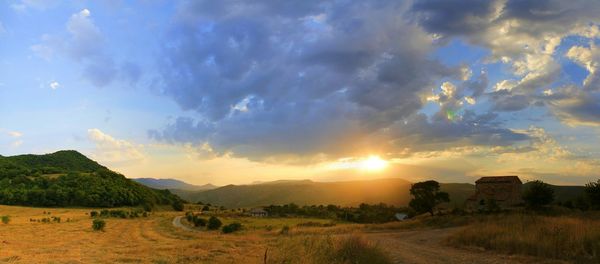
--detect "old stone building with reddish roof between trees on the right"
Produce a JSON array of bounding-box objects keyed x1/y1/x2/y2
[{"x1": 465, "y1": 176, "x2": 523, "y2": 210}]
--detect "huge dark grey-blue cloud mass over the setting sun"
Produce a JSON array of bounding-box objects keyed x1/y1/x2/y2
[{"x1": 149, "y1": 1, "x2": 523, "y2": 160}]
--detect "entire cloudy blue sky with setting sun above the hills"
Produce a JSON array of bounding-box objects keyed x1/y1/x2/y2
[{"x1": 0, "y1": 0, "x2": 600, "y2": 185}]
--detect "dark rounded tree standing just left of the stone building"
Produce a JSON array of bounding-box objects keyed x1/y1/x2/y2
[{"x1": 409, "y1": 181, "x2": 450, "y2": 216}]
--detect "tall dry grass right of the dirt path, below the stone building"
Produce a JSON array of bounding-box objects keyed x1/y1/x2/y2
[{"x1": 448, "y1": 214, "x2": 600, "y2": 263}]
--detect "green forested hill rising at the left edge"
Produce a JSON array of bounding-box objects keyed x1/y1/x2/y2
[{"x1": 0, "y1": 151, "x2": 180, "y2": 207}]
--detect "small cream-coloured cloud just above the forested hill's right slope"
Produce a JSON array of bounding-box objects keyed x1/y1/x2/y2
[{"x1": 88, "y1": 128, "x2": 145, "y2": 166}]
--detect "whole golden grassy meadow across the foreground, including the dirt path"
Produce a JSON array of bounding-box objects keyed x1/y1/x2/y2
[{"x1": 0, "y1": 206, "x2": 600, "y2": 263}]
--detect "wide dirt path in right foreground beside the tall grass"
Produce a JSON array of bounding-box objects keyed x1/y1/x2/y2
[{"x1": 365, "y1": 228, "x2": 564, "y2": 264}]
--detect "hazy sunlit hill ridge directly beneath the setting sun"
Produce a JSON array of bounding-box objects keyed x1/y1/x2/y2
[{"x1": 173, "y1": 178, "x2": 474, "y2": 208}]
